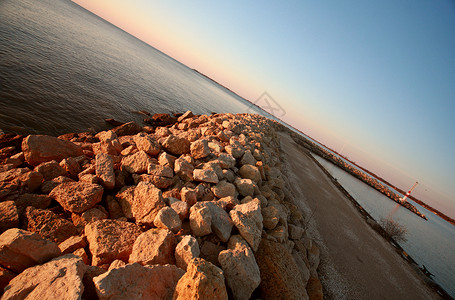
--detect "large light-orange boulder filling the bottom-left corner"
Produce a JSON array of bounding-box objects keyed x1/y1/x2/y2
[{"x1": 2, "y1": 254, "x2": 87, "y2": 300}]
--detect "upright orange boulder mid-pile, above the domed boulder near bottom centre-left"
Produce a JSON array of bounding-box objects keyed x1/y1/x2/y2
[{"x1": 131, "y1": 181, "x2": 166, "y2": 226}]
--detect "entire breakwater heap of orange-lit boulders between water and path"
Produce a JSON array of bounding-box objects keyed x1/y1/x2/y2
[{"x1": 0, "y1": 112, "x2": 322, "y2": 299}]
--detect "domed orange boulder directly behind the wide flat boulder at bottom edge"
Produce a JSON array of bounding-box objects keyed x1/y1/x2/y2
[{"x1": 129, "y1": 228, "x2": 176, "y2": 265}]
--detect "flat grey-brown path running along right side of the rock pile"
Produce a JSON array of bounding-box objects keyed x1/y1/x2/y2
[{"x1": 280, "y1": 133, "x2": 439, "y2": 299}]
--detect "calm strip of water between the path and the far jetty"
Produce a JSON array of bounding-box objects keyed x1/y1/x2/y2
[{"x1": 314, "y1": 155, "x2": 455, "y2": 297}]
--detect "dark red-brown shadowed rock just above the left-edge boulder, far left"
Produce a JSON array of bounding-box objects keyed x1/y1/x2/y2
[{"x1": 25, "y1": 206, "x2": 77, "y2": 243}]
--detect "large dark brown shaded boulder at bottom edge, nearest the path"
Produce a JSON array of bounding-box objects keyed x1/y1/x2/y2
[{"x1": 256, "y1": 239, "x2": 308, "y2": 300}]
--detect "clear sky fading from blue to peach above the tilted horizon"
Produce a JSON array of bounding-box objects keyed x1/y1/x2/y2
[{"x1": 74, "y1": 0, "x2": 455, "y2": 218}]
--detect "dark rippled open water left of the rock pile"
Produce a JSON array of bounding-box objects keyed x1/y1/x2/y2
[{"x1": 0, "y1": 0, "x2": 268, "y2": 135}]
